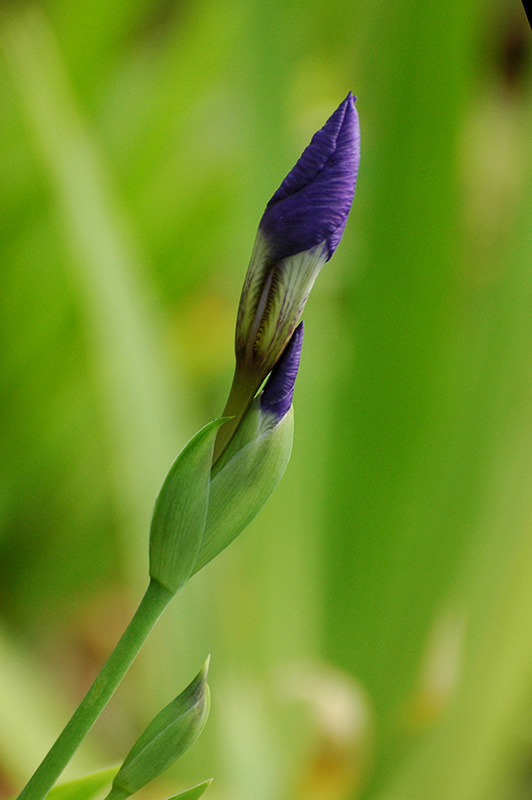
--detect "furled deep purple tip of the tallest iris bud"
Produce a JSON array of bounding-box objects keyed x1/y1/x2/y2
[{"x1": 260, "y1": 92, "x2": 360, "y2": 259}]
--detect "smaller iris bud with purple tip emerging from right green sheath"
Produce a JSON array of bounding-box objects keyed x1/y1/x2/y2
[{"x1": 194, "y1": 323, "x2": 303, "y2": 572}]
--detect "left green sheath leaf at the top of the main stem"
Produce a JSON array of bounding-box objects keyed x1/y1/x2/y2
[{"x1": 150, "y1": 418, "x2": 226, "y2": 593}]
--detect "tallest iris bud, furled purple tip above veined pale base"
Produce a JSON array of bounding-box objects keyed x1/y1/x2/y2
[{"x1": 214, "y1": 92, "x2": 360, "y2": 460}]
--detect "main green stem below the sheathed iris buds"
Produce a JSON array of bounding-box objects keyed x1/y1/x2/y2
[{"x1": 19, "y1": 580, "x2": 173, "y2": 800}]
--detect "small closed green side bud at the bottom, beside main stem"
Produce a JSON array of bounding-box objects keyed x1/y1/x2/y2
[{"x1": 107, "y1": 659, "x2": 209, "y2": 800}]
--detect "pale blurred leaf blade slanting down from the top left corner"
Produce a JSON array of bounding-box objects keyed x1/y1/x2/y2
[{"x1": 1, "y1": 6, "x2": 184, "y2": 573}]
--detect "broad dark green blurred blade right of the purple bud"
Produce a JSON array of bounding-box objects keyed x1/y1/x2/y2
[{"x1": 324, "y1": 0, "x2": 486, "y2": 788}]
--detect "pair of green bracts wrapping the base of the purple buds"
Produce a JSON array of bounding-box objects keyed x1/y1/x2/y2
[{"x1": 150, "y1": 398, "x2": 294, "y2": 592}]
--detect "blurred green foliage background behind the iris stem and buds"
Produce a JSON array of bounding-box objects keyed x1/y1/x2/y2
[{"x1": 0, "y1": 0, "x2": 532, "y2": 800}]
